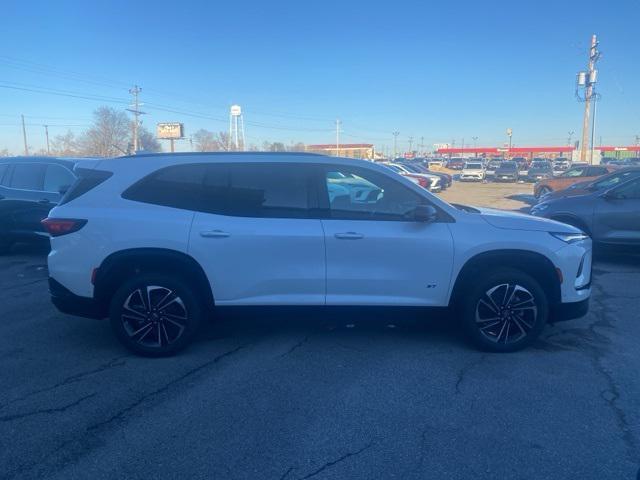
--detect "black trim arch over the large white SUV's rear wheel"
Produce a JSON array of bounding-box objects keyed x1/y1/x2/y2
[{"x1": 93, "y1": 248, "x2": 215, "y2": 314}]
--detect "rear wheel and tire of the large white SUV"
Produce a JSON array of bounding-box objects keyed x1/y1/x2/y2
[{"x1": 109, "y1": 273, "x2": 204, "y2": 357}]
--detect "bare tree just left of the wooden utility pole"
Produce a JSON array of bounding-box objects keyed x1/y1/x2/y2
[{"x1": 78, "y1": 107, "x2": 131, "y2": 157}]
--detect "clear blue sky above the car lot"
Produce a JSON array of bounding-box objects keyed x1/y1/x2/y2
[{"x1": 0, "y1": 0, "x2": 640, "y2": 153}]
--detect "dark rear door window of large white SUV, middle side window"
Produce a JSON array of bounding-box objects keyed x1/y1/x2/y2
[{"x1": 227, "y1": 163, "x2": 312, "y2": 218}]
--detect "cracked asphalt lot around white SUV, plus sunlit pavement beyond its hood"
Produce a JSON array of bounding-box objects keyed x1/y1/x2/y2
[{"x1": 0, "y1": 184, "x2": 640, "y2": 480}]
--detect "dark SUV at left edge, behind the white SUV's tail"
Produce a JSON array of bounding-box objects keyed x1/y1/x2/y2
[{"x1": 0, "y1": 157, "x2": 81, "y2": 253}]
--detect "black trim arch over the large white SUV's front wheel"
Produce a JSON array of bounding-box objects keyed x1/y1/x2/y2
[{"x1": 449, "y1": 249, "x2": 561, "y2": 306}]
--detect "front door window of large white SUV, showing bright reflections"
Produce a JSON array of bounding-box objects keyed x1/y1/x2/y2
[{"x1": 325, "y1": 166, "x2": 425, "y2": 221}]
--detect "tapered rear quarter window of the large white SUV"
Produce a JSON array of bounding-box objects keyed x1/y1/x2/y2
[{"x1": 122, "y1": 164, "x2": 208, "y2": 211}]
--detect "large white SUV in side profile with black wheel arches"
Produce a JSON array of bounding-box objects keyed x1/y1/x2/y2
[{"x1": 43, "y1": 153, "x2": 591, "y2": 355}]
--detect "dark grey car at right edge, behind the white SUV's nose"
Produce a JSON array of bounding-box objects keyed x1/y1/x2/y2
[{"x1": 531, "y1": 175, "x2": 640, "y2": 246}]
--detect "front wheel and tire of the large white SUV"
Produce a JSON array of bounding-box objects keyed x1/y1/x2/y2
[{"x1": 459, "y1": 268, "x2": 549, "y2": 352}]
